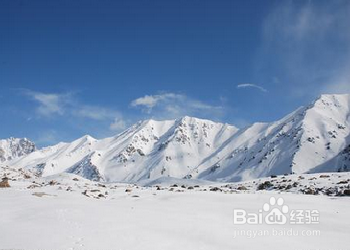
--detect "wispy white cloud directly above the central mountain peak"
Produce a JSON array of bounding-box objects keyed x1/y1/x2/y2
[{"x1": 131, "y1": 93, "x2": 225, "y2": 119}]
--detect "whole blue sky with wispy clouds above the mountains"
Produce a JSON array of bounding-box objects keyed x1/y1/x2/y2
[{"x1": 0, "y1": 0, "x2": 350, "y2": 146}]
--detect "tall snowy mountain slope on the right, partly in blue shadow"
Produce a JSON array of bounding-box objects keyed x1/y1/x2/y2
[{"x1": 198, "y1": 95, "x2": 350, "y2": 181}]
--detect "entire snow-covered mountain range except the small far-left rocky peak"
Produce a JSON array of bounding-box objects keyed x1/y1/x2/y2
[{"x1": 0, "y1": 95, "x2": 350, "y2": 182}]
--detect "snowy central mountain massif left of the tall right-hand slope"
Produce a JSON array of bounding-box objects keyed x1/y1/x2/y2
[{"x1": 4, "y1": 117, "x2": 238, "y2": 181}]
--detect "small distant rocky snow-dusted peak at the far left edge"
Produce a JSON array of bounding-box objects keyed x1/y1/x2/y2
[{"x1": 0, "y1": 137, "x2": 36, "y2": 162}]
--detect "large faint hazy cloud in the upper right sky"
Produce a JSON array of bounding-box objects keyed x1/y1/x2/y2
[{"x1": 257, "y1": 0, "x2": 350, "y2": 96}]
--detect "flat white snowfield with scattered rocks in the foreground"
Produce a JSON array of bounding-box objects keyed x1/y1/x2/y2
[{"x1": 0, "y1": 170, "x2": 350, "y2": 250}]
